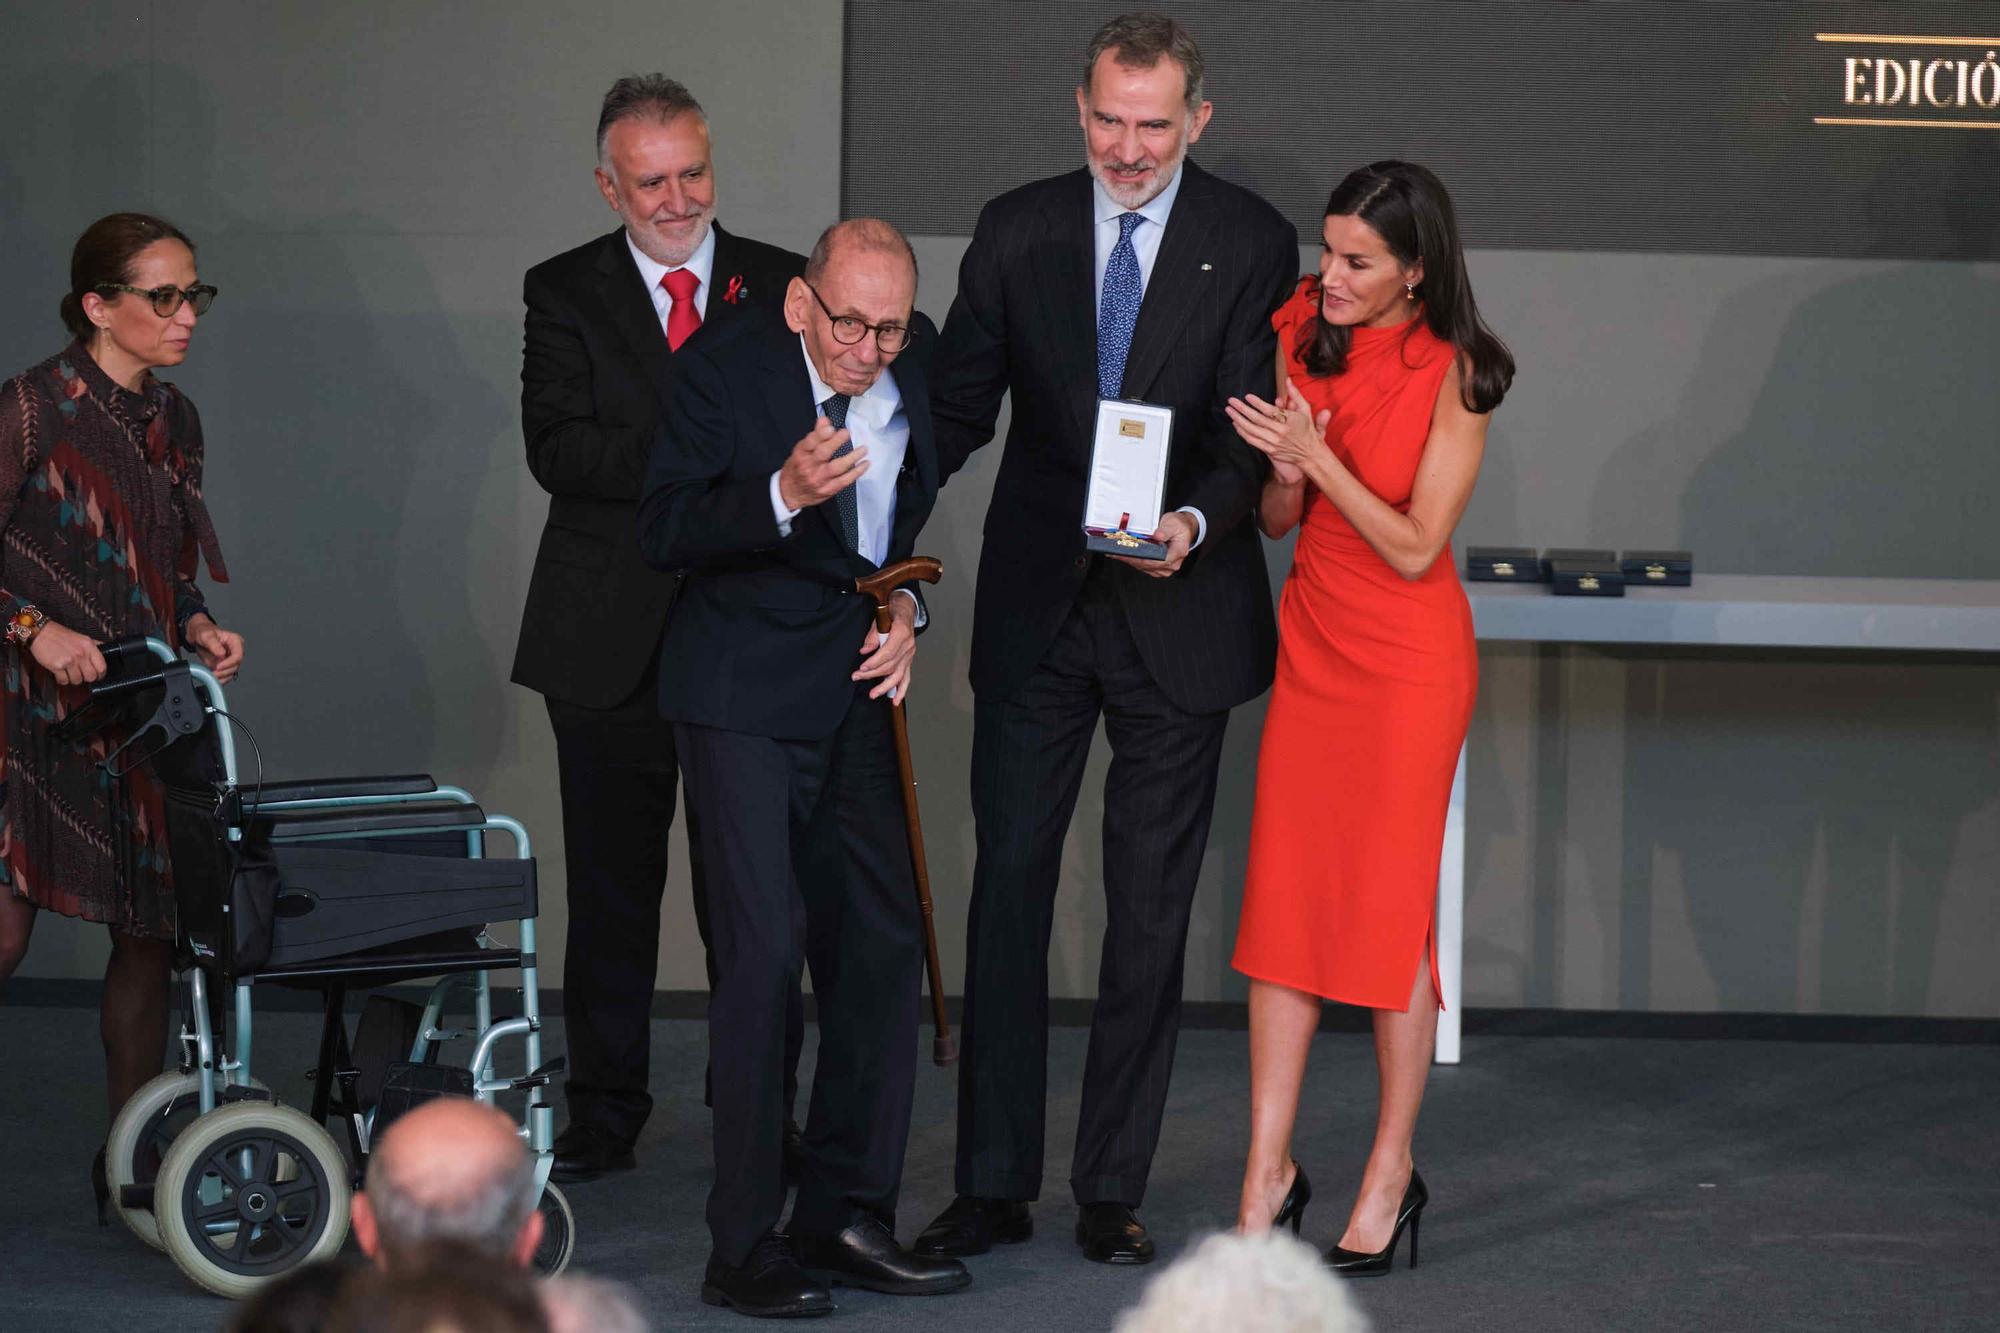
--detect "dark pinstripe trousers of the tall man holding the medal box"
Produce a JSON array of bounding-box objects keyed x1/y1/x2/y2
[{"x1": 956, "y1": 568, "x2": 1228, "y2": 1207}]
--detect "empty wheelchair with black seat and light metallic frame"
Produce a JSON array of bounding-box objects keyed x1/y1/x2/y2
[{"x1": 75, "y1": 638, "x2": 576, "y2": 1297}]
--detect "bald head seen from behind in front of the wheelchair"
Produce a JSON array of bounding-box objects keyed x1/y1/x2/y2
[{"x1": 354, "y1": 1097, "x2": 542, "y2": 1269}]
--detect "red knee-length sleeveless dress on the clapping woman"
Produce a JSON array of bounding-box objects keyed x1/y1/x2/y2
[{"x1": 1234, "y1": 278, "x2": 1478, "y2": 1011}]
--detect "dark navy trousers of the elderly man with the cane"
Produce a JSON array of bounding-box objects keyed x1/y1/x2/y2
[{"x1": 676, "y1": 685, "x2": 924, "y2": 1265}]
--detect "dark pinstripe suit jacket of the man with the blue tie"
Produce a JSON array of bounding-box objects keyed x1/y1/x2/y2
[{"x1": 932, "y1": 162, "x2": 1298, "y2": 713}]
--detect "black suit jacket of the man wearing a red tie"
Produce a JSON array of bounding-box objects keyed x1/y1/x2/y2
[{"x1": 514, "y1": 226, "x2": 806, "y2": 709}]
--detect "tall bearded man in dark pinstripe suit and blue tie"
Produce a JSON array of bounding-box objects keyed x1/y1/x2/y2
[{"x1": 918, "y1": 14, "x2": 1298, "y2": 1263}]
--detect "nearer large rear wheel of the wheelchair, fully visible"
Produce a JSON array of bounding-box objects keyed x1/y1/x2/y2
[{"x1": 154, "y1": 1101, "x2": 352, "y2": 1299}]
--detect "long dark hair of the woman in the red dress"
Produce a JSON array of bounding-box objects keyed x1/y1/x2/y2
[{"x1": 1300, "y1": 162, "x2": 1514, "y2": 412}]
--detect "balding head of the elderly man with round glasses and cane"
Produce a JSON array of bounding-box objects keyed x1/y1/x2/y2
[{"x1": 784, "y1": 218, "x2": 916, "y2": 396}]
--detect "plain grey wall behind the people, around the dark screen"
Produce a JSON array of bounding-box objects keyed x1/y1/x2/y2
[{"x1": 0, "y1": 0, "x2": 2000, "y2": 1017}]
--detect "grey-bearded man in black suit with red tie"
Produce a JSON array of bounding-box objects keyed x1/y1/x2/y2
[{"x1": 514, "y1": 74, "x2": 806, "y2": 1181}]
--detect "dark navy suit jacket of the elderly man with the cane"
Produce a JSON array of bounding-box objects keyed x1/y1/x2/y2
[{"x1": 638, "y1": 314, "x2": 938, "y2": 741}]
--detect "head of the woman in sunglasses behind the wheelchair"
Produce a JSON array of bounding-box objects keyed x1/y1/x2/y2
[{"x1": 62, "y1": 212, "x2": 214, "y2": 374}]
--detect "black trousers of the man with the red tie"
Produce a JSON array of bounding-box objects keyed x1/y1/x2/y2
[{"x1": 546, "y1": 671, "x2": 806, "y2": 1143}]
